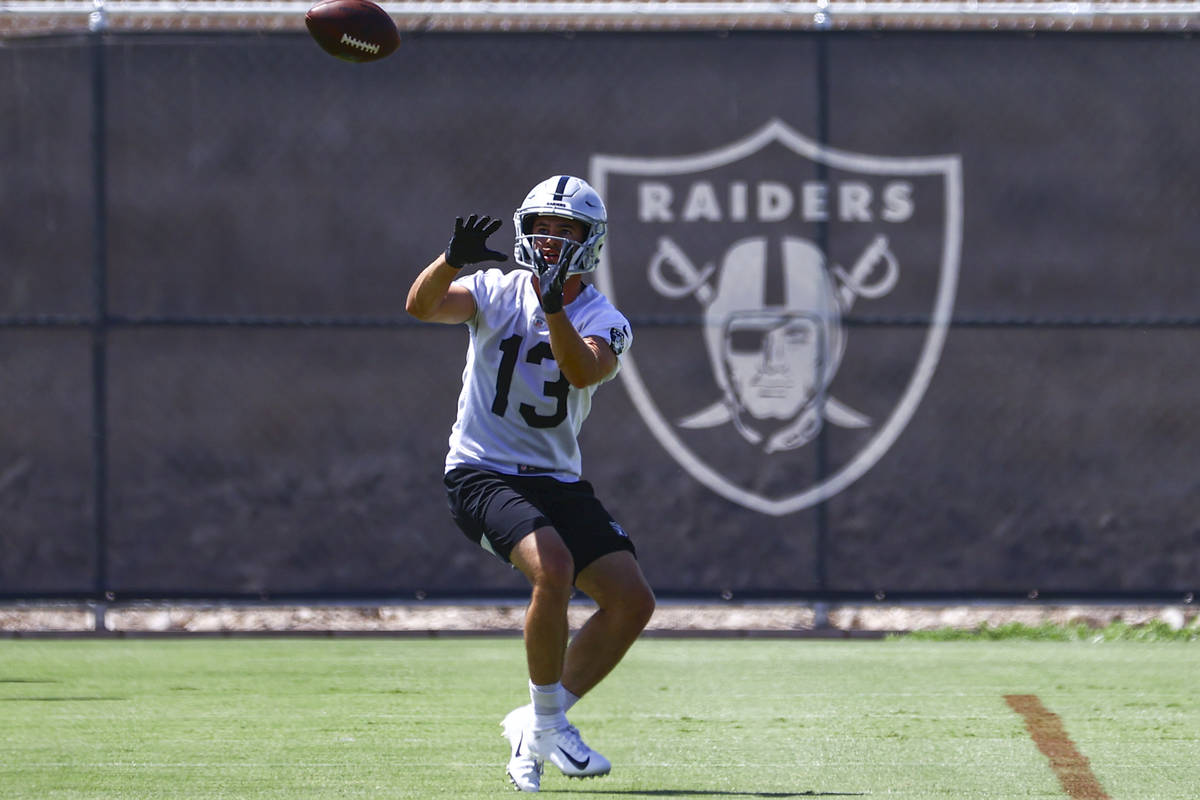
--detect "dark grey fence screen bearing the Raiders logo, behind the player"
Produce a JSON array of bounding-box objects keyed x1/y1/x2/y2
[{"x1": 0, "y1": 32, "x2": 1200, "y2": 597}]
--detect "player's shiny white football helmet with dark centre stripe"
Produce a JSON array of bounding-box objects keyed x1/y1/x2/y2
[{"x1": 512, "y1": 175, "x2": 608, "y2": 276}]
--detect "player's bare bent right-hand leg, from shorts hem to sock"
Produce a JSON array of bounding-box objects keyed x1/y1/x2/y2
[{"x1": 563, "y1": 551, "x2": 654, "y2": 697}]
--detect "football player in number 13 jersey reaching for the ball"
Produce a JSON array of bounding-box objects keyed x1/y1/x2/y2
[{"x1": 406, "y1": 175, "x2": 654, "y2": 792}]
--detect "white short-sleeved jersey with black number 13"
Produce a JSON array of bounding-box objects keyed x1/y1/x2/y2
[{"x1": 446, "y1": 269, "x2": 632, "y2": 481}]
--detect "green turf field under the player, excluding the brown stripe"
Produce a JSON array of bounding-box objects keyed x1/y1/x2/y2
[{"x1": 0, "y1": 637, "x2": 1200, "y2": 800}]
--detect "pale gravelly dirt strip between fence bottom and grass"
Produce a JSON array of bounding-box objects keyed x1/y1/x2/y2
[{"x1": 0, "y1": 602, "x2": 1200, "y2": 636}]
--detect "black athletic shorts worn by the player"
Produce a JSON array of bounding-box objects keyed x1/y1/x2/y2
[{"x1": 445, "y1": 467, "x2": 637, "y2": 576}]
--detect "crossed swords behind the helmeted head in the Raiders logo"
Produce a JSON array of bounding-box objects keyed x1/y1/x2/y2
[{"x1": 647, "y1": 234, "x2": 900, "y2": 438}]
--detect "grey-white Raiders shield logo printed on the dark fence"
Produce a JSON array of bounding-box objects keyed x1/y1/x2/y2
[{"x1": 590, "y1": 120, "x2": 962, "y2": 515}]
